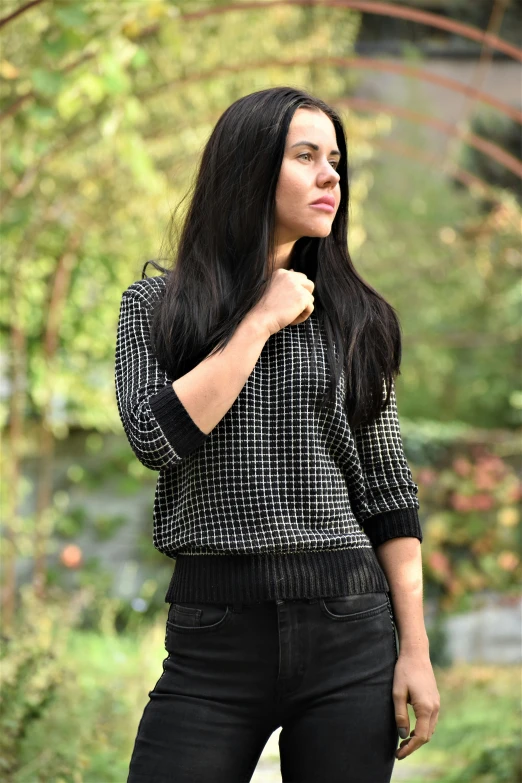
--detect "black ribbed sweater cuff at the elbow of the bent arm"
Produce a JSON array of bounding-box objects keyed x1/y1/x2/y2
[{"x1": 149, "y1": 384, "x2": 208, "y2": 457}]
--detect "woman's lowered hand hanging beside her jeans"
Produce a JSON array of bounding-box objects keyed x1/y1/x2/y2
[{"x1": 392, "y1": 650, "x2": 440, "y2": 760}]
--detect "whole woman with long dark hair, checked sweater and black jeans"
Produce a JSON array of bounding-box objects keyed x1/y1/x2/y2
[{"x1": 116, "y1": 87, "x2": 439, "y2": 783}]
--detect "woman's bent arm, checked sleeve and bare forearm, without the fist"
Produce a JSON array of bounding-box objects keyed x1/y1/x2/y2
[{"x1": 115, "y1": 292, "x2": 270, "y2": 470}]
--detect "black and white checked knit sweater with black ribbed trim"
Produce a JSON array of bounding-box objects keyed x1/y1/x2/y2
[{"x1": 115, "y1": 275, "x2": 422, "y2": 602}]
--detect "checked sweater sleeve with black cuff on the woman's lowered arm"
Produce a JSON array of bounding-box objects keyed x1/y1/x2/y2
[{"x1": 354, "y1": 376, "x2": 423, "y2": 549}]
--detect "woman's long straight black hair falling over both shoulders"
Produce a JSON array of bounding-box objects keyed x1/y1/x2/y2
[{"x1": 142, "y1": 87, "x2": 401, "y2": 427}]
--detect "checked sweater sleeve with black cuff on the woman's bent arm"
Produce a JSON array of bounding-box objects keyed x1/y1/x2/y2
[{"x1": 115, "y1": 290, "x2": 208, "y2": 470}]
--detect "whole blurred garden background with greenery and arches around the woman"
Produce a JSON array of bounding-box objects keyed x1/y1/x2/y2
[{"x1": 0, "y1": 0, "x2": 522, "y2": 783}]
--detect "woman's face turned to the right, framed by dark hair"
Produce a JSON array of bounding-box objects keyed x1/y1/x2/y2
[{"x1": 276, "y1": 109, "x2": 341, "y2": 245}]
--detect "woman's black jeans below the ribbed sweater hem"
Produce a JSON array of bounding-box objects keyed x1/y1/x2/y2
[{"x1": 127, "y1": 593, "x2": 399, "y2": 783}]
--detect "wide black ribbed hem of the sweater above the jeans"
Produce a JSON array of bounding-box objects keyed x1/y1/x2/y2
[{"x1": 165, "y1": 547, "x2": 390, "y2": 603}]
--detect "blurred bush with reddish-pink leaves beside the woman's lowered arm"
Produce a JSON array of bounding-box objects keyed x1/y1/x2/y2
[{"x1": 416, "y1": 445, "x2": 522, "y2": 610}]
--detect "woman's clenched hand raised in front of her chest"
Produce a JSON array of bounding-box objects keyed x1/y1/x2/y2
[{"x1": 250, "y1": 269, "x2": 315, "y2": 335}]
